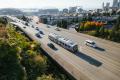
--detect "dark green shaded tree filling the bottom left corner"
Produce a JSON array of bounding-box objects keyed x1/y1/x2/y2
[{"x1": 0, "y1": 42, "x2": 25, "y2": 80}]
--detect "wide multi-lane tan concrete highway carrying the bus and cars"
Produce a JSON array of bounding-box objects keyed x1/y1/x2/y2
[{"x1": 9, "y1": 17, "x2": 120, "y2": 80}]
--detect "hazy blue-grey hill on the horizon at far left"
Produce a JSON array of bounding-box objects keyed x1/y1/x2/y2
[{"x1": 0, "y1": 8, "x2": 24, "y2": 15}]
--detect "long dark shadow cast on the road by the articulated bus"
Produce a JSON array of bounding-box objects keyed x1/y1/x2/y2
[{"x1": 75, "y1": 51, "x2": 102, "y2": 67}]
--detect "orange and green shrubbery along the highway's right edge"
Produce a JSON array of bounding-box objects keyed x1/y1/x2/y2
[{"x1": 76, "y1": 16, "x2": 120, "y2": 42}]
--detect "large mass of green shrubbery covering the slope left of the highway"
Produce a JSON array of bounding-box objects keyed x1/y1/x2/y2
[{"x1": 0, "y1": 21, "x2": 73, "y2": 80}]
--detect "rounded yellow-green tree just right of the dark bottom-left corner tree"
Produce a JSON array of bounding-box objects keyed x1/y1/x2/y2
[{"x1": 22, "y1": 50, "x2": 48, "y2": 80}]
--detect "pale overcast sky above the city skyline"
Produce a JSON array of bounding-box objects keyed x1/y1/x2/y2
[{"x1": 0, "y1": 0, "x2": 113, "y2": 9}]
